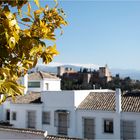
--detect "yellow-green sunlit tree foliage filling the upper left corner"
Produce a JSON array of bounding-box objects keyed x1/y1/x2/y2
[{"x1": 0, "y1": 0, "x2": 67, "y2": 103}]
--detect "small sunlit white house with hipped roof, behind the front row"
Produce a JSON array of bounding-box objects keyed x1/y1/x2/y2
[{"x1": 19, "y1": 71, "x2": 61, "y2": 94}]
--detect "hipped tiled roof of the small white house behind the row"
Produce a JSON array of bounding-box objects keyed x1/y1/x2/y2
[{"x1": 28, "y1": 71, "x2": 59, "y2": 80}]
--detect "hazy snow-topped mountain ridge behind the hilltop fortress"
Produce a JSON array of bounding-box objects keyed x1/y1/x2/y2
[{"x1": 31, "y1": 62, "x2": 140, "y2": 80}]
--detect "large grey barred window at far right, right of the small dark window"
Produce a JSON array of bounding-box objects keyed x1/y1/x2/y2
[{"x1": 121, "y1": 120, "x2": 136, "y2": 139}]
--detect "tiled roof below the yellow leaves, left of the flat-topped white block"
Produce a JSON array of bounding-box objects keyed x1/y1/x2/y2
[{"x1": 8, "y1": 92, "x2": 42, "y2": 104}]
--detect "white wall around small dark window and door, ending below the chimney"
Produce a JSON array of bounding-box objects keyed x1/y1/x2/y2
[{"x1": 76, "y1": 110, "x2": 119, "y2": 139}]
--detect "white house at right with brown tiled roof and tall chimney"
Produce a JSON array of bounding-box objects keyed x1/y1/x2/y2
[{"x1": 77, "y1": 90, "x2": 140, "y2": 139}]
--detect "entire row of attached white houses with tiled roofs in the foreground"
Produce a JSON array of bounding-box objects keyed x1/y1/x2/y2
[{"x1": 0, "y1": 71, "x2": 140, "y2": 139}]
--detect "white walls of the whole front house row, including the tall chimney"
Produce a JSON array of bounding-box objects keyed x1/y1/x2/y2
[{"x1": 1, "y1": 84, "x2": 140, "y2": 139}]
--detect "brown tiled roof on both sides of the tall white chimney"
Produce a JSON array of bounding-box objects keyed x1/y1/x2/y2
[{"x1": 78, "y1": 92, "x2": 140, "y2": 112}]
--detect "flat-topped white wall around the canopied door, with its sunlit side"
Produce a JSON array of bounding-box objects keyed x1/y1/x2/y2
[{"x1": 41, "y1": 90, "x2": 94, "y2": 137}]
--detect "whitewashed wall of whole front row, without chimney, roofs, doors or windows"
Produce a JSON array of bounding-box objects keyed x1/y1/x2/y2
[{"x1": 2, "y1": 90, "x2": 140, "y2": 139}]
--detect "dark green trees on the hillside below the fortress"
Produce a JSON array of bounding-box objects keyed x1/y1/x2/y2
[{"x1": 61, "y1": 70, "x2": 140, "y2": 91}]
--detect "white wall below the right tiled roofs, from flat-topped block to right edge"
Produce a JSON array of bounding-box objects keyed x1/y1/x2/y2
[{"x1": 76, "y1": 110, "x2": 140, "y2": 139}]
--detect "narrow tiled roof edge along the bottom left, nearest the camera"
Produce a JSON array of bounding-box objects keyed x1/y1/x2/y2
[{"x1": 0, "y1": 126, "x2": 80, "y2": 140}]
